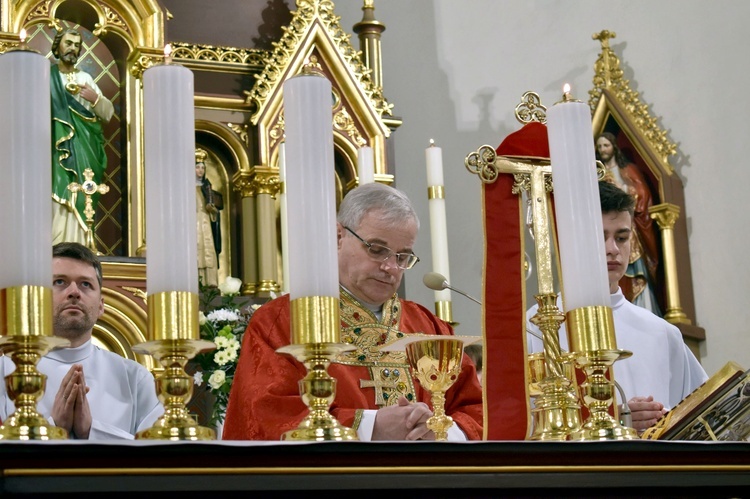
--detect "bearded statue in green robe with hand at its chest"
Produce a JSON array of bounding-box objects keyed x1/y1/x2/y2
[{"x1": 50, "y1": 28, "x2": 114, "y2": 244}]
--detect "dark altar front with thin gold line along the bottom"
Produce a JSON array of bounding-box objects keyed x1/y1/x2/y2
[{"x1": 0, "y1": 441, "x2": 750, "y2": 497}]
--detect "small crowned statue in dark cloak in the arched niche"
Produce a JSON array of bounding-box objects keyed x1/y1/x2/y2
[{"x1": 195, "y1": 148, "x2": 224, "y2": 286}]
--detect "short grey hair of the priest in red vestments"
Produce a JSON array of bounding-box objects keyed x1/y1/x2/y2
[{"x1": 337, "y1": 182, "x2": 419, "y2": 230}]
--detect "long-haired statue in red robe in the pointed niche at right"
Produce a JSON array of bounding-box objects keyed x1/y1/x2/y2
[{"x1": 596, "y1": 132, "x2": 662, "y2": 317}]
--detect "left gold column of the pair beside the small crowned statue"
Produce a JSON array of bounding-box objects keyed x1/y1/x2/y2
[{"x1": 232, "y1": 172, "x2": 258, "y2": 295}]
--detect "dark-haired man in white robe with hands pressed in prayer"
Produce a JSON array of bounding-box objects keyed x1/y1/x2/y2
[{"x1": 0, "y1": 243, "x2": 164, "y2": 440}]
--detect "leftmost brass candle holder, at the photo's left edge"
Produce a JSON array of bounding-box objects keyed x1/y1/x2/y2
[{"x1": 0, "y1": 286, "x2": 70, "y2": 440}]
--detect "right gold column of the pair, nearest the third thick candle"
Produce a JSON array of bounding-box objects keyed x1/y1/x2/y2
[{"x1": 253, "y1": 166, "x2": 281, "y2": 296}]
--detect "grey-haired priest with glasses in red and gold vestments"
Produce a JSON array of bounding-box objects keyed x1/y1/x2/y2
[{"x1": 223, "y1": 183, "x2": 482, "y2": 441}]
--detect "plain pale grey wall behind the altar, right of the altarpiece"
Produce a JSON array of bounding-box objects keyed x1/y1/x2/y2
[{"x1": 335, "y1": 0, "x2": 750, "y2": 374}]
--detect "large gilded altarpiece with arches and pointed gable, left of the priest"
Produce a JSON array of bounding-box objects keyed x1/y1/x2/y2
[{"x1": 0, "y1": 0, "x2": 401, "y2": 376}]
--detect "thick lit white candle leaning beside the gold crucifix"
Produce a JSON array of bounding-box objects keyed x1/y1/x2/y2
[{"x1": 547, "y1": 88, "x2": 611, "y2": 312}]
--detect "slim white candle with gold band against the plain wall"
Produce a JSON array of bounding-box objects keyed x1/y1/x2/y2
[{"x1": 425, "y1": 140, "x2": 451, "y2": 301}]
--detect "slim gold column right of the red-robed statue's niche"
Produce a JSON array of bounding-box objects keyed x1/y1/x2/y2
[{"x1": 648, "y1": 203, "x2": 691, "y2": 324}]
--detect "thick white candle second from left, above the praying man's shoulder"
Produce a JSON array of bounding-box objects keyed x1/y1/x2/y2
[{"x1": 143, "y1": 57, "x2": 198, "y2": 294}]
